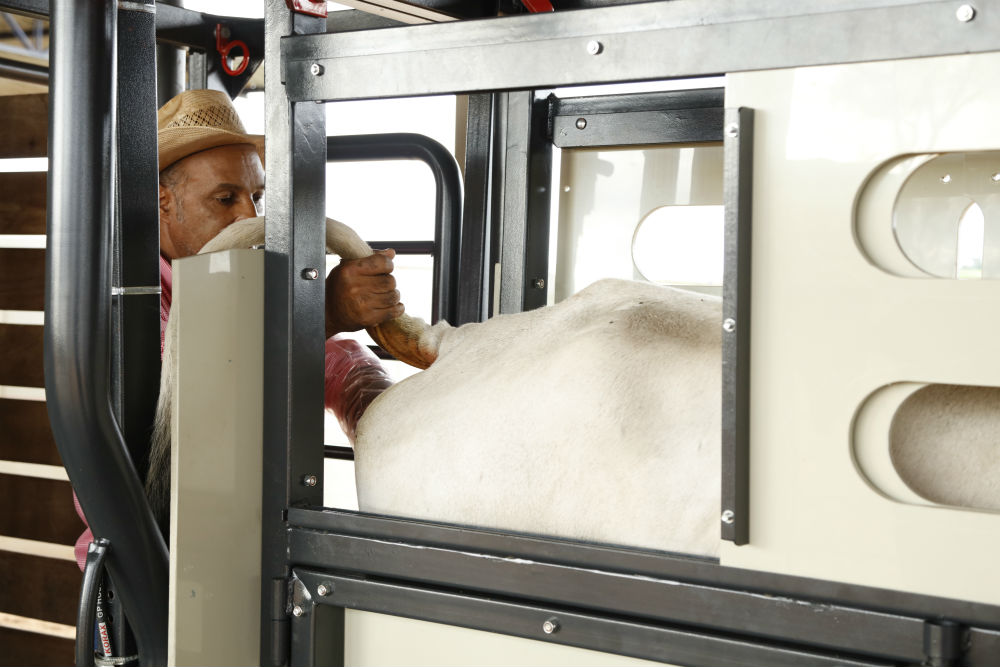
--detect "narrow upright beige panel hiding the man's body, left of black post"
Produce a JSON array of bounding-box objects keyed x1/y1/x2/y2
[{"x1": 167, "y1": 250, "x2": 264, "y2": 665}]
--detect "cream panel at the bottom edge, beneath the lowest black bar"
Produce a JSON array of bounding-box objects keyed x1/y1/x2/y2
[{"x1": 344, "y1": 609, "x2": 662, "y2": 667}]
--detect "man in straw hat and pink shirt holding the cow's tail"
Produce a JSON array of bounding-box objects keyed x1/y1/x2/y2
[{"x1": 76, "y1": 90, "x2": 403, "y2": 569}]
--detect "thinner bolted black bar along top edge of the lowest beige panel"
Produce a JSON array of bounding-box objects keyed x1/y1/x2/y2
[{"x1": 295, "y1": 569, "x2": 891, "y2": 667}]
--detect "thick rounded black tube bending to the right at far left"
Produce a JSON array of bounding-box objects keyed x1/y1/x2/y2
[{"x1": 45, "y1": 0, "x2": 167, "y2": 665}]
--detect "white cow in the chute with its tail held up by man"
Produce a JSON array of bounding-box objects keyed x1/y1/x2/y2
[{"x1": 147, "y1": 218, "x2": 1000, "y2": 556}]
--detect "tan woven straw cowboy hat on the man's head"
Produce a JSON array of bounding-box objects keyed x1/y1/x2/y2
[{"x1": 156, "y1": 90, "x2": 264, "y2": 171}]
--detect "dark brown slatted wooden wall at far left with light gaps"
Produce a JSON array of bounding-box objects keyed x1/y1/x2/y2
[{"x1": 0, "y1": 94, "x2": 83, "y2": 667}]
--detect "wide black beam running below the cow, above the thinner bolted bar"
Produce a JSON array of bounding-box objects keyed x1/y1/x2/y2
[{"x1": 289, "y1": 529, "x2": 924, "y2": 662}]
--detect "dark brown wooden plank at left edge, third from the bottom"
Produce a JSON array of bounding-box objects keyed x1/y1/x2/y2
[{"x1": 0, "y1": 473, "x2": 84, "y2": 545}]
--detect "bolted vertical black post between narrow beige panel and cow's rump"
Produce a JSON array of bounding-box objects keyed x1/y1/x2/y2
[{"x1": 261, "y1": 0, "x2": 326, "y2": 665}]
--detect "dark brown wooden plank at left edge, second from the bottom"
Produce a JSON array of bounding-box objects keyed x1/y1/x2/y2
[{"x1": 0, "y1": 551, "x2": 83, "y2": 628}]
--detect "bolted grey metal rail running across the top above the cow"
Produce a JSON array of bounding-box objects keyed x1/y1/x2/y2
[{"x1": 281, "y1": 0, "x2": 1000, "y2": 102}]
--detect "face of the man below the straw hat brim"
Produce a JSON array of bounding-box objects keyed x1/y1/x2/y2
[{"x1": 160, "y1": 144, "x2": 264, "y2": 259}]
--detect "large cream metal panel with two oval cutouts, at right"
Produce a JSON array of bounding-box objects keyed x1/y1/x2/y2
[{"x1": 721, "y1": 54, "x2": 1000, "y2": 604}]
